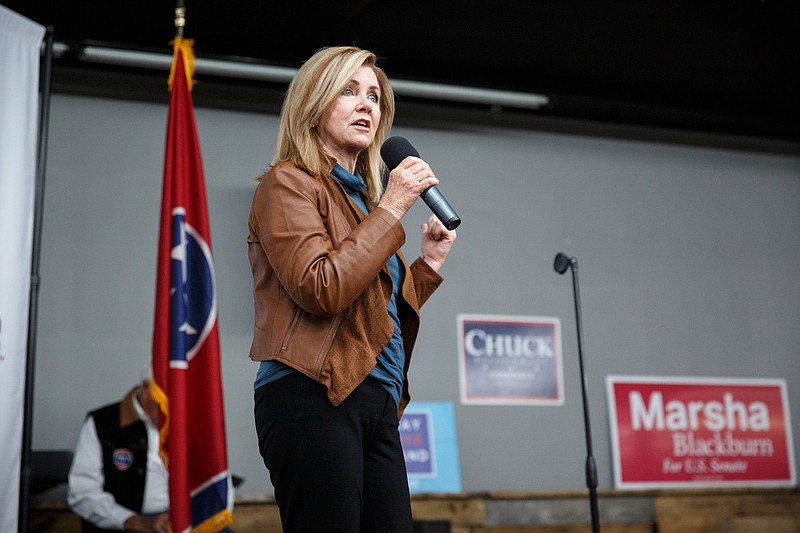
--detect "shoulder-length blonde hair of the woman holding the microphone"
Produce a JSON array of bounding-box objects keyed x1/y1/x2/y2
[{"x1": 272, "y1": 46, "x2": 394, "y2": 203}]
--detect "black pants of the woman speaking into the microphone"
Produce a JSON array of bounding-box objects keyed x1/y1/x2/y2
[{"x1": 255, "y1": 372, "x2": 413, "y2": 533}]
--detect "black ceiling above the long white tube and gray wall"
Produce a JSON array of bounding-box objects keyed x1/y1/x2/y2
[{"x1": 2, "y1": 0, "x2": 800, "y2": 143}]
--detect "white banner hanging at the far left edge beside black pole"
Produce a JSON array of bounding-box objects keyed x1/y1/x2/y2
[{"x1": 0, "y1": 6, "x2": 45, "y2": 531}]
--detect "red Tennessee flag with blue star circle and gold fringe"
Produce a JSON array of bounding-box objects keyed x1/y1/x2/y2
[{"x1": 151, "y1": 37, "x2": 233, "y2": 533}]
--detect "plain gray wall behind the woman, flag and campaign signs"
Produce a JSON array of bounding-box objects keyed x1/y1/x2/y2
[{"x1": 33, "y1": 95, "x2": 800, "y2": 496}]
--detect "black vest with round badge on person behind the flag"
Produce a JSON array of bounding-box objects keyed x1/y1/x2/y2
[{"x1": 82, "y1": 402, "x2": 147, "y2": 533}]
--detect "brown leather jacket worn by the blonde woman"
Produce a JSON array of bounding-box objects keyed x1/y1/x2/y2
[{"x1": 247, "y1": 163, "x2": 442, "y2": 414}]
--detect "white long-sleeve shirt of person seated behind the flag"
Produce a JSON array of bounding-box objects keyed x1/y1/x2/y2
[{"x1": 67, "y1": 388, "x2": 169, "y2": 529}]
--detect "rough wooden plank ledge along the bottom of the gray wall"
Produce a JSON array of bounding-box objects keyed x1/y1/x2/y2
[{"x1": 30, "y1": 489, "x2": 800, "y2": 533}]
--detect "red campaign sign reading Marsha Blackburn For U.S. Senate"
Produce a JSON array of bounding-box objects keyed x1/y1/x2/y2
[{"x1": 606, "y1": 376, "x2": 796, "y2": 489}]
